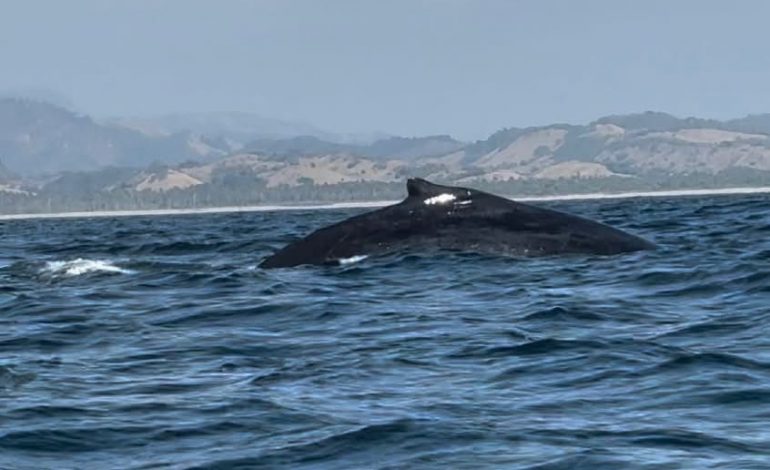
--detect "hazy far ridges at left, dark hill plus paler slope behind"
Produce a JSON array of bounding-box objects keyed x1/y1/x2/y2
[{"x1": 0, "y1": 97, "x2": 396, "y2": 176}]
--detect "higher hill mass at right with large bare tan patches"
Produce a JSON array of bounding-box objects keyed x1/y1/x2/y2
[{"x1": 444, "y1": 112, "x2": 770, "y2": 180}]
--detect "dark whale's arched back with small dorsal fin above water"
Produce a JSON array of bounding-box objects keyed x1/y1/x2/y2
[{"x1": 259, "y1": 178, "x2": 655, "y2": 269}]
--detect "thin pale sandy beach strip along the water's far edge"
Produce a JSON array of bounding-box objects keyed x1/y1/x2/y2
[{"x1": 0, "y1": 186, "x2": 770, "y2": 221}]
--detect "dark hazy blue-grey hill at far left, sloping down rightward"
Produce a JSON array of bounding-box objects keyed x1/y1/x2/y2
[{"x1": 0, "y1": 98, "x2": 229, "y2": 175}]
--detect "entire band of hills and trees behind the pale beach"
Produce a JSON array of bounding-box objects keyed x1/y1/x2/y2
[{"x1": 0, "y1": 99, "x2": 770, "y2": 212}]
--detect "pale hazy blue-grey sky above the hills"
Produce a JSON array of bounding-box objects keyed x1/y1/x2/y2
[{"x1": 0, "y1": 0, "x2": 770, "y2": 139}]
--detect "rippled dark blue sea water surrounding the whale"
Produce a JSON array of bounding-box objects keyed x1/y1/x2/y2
[{"x1": 0, "y1": 196, "x2": 770, "y2": 469}]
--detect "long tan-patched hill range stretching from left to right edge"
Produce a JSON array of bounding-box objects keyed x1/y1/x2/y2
[{"x1": 76, "y1": 113, "x2": 770, "y2": 192}]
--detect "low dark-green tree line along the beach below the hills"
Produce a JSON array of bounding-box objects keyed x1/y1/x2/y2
[{"x1": 0, "y1": 169, "x2": 770, "y2": 214}]
